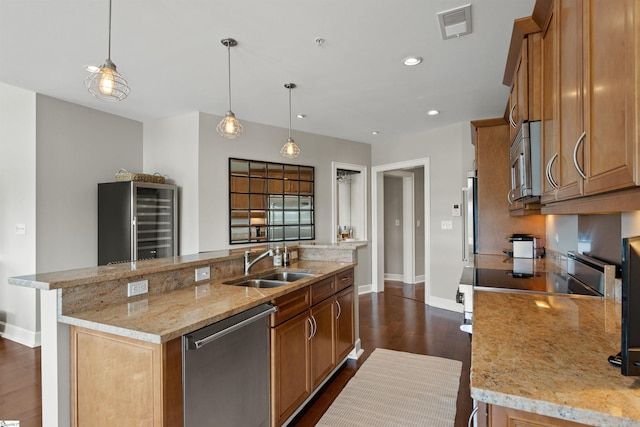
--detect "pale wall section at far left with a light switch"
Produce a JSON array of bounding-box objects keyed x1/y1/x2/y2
[{"x1": 0, "y1": 83, "x2": 40, "y2": 347}]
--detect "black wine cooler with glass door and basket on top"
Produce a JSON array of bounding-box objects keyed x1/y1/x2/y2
[{"x1": 98, "y1": 181, "x2": 178, "y2": 265}]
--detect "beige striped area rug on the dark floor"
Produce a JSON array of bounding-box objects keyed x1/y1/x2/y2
[{"x1": 317, "y1": 348, "x2": 462, "y2": 427}]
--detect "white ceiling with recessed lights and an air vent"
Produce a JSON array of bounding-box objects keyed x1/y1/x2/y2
[{"x1": 0, "y1": 0, "x2": 534, "y2": 144}]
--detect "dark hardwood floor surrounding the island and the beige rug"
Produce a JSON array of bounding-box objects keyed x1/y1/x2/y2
[{"x1": 0, "y1": 282, "x2": 472, "y2": 427}]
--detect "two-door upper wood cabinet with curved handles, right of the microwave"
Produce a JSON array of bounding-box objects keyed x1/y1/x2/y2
[{"x1": 543, "y1": 0, "x2": 640, "y2": 206}]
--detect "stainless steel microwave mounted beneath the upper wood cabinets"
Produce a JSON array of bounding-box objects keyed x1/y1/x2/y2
[{"x1": 507, "y1": 121, "x2": 542, "y2": 203}]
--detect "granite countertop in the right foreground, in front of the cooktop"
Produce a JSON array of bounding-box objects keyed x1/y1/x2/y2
[{"x1": 471, "y1": 290, "x2": 640, "y2": 426}]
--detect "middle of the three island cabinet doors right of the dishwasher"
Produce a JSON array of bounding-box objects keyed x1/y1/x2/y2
[{"x1": 311, "y1": 297, "x2": 336, "y2": 388}]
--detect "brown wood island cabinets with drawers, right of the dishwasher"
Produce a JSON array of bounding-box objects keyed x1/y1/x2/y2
[{"x1": 271, "y1": 269, "x2": 355, "y2": 426}]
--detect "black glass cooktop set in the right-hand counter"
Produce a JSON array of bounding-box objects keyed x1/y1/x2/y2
[{"x1": 473, "y1": 268, "x2": 602, "y2": 296}]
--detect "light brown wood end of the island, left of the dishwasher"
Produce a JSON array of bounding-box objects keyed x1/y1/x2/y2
[{"x1": 71, "y1": 326, "x2": 183, "y2": 427}]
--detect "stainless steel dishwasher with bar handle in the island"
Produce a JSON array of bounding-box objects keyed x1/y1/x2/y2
[{"x1": 182, "y1": 304, "x2": 276, "y2": 427}]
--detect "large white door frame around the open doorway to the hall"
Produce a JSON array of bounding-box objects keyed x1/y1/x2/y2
[{"x1": 371, "y1": 157, "x2": 431, "y2": 304}]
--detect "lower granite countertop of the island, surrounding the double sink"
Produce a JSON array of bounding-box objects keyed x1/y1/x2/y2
[{"x1": 59, "y1": 261, "x2": 355, "y2": 343}]
